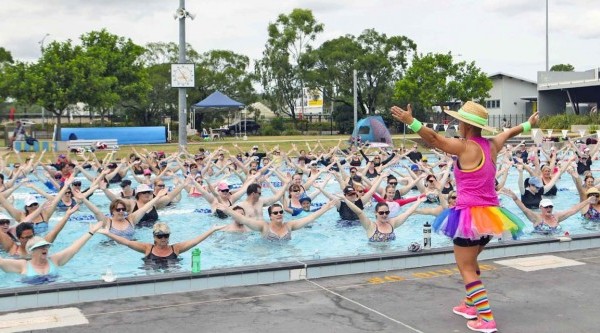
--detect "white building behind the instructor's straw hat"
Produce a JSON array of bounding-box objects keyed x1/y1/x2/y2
[{"x1": 485, "y1": 72, "x2": 538, "y2": 127}]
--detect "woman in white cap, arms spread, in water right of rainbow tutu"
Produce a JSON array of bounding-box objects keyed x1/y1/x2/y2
[{"x1": 501, "y1": 188, "x2": 596, "y2": 235}]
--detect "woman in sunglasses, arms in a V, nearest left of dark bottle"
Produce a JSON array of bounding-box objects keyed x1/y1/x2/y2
[{"x1": 342, "y1": 197, "x2": 424, "y2": 243}]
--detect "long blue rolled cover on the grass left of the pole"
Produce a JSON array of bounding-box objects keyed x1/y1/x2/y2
[{"x1": 60, "y1": 126, "x2": 167, "y2": 145}]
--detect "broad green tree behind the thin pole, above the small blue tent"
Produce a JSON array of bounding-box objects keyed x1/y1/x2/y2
[{"x1": 309, "y1": 29, "x2": 417, "y2": 114}]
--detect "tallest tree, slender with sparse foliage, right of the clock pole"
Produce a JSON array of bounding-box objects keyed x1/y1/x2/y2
[{"x1": 255, "y1": 8, "x2": 323, "y2": 121}]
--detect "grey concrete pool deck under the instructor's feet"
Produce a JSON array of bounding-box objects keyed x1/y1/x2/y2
[{"x1": 0, "y1": 235, "x2": 600, "y2": 332}]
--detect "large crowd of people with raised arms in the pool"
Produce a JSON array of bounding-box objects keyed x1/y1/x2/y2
[{"x1": 0, "y1": 130, "x2": 600, "y2": 277}]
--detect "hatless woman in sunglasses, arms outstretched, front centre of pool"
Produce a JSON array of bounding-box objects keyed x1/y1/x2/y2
[{"x1": 219, "y1": 200, "x2": 338, "y2": 241}]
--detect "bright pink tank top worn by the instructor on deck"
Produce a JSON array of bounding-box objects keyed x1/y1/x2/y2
[{"x1": 454, "y1": 137, "x2": 500, "y2": 209}]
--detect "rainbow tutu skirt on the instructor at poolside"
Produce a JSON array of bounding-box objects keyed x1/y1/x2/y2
[{"x1": 431, "y1": 206, "x2": 525, "y2": 240}]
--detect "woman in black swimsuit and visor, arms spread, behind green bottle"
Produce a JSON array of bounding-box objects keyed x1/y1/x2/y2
[{"x1": 98, "y1": 222, "x2": 225, "y2": 263}]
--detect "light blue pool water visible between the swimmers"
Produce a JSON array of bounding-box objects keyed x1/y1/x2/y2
[{"x1": 0, "y1": 157, "x2": 600, "y2": 288}]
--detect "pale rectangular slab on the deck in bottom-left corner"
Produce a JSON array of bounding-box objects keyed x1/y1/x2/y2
[{"x1": 0, "y1": 307, "x2": 89, "y2": 332}]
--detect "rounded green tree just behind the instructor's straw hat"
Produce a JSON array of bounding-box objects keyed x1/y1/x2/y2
[{"x1": 394, "y1": 53, "x2": 492, "y2": 111}]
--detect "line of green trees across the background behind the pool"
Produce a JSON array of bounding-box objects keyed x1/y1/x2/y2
[{"x1": 0, "y1": 8, "x2": 491, "y2": 137}]
